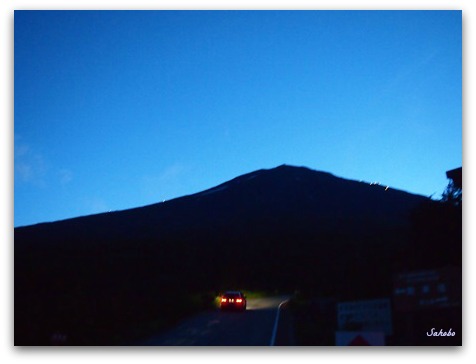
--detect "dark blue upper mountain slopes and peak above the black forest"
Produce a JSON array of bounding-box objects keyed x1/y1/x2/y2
[{"x1": 15, "y1": 165, "x2": 425, "y2": 246}]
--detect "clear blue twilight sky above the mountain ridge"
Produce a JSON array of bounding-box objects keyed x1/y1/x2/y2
[{"x1": 14, "y1": 11, "x2": 462, "y2": 226}]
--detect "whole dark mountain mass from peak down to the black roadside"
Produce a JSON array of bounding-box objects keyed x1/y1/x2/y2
[{"x1": 14, "y1": 165, "x2": 461, "y2": 345}]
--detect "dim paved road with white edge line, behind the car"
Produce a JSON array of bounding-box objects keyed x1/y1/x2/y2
[{"x1": 141, "y1": 296, "x2": 288, "y2": 346}]
